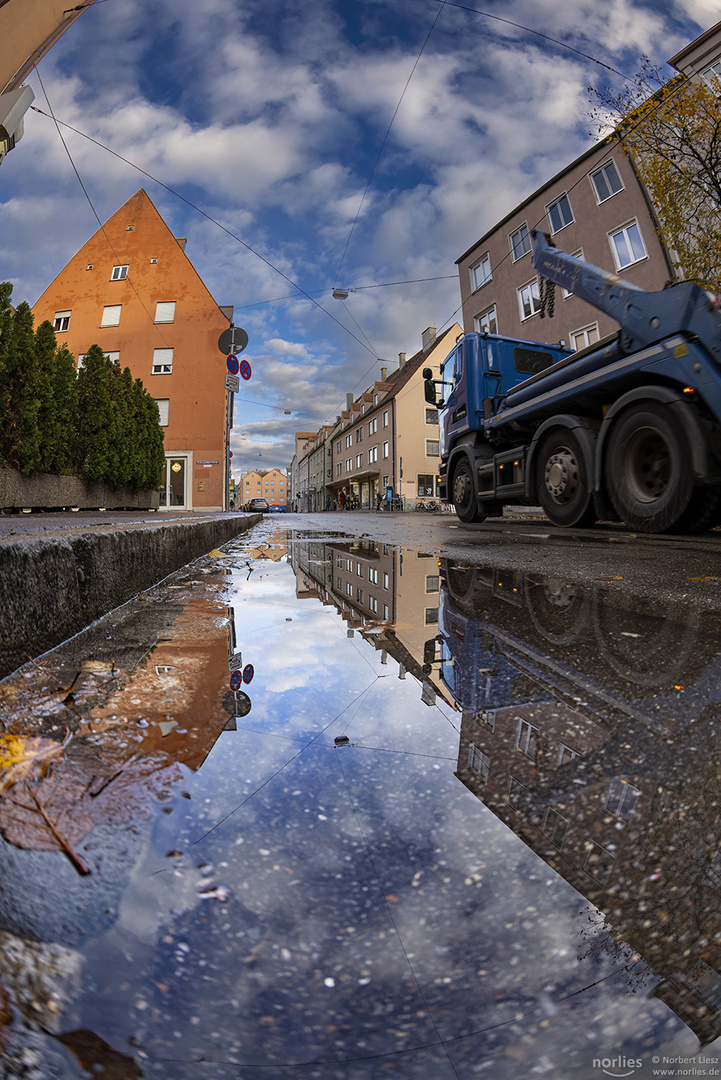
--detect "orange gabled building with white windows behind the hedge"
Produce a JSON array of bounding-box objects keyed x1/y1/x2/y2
[{"x1": 32, "y1": 190, "x2": 233, "y2": 510}]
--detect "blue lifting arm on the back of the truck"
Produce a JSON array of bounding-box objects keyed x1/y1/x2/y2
[{"x1": 531, "y1": 229, "x2": 721, "y2": 367}]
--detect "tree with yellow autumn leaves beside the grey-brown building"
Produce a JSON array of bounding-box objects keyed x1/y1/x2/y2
[{"x1": 590, "y1": 57, "x2": 721, "y2": 293}]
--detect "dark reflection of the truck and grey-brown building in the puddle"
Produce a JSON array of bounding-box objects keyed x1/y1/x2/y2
[{"x1": 438, "y1": 563, "x2": 721, "y2": 1044}]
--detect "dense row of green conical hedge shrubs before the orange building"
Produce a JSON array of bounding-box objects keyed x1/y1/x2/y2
[{"x1": 0, "y1": 282, "x2": 165, "y2": 488}]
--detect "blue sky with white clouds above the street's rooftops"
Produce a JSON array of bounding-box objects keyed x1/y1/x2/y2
[{"x1": 0, "y1": 0, "x2": 719, "y2": 476}]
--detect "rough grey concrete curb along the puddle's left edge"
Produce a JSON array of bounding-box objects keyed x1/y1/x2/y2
[{"x1": 0, "y1": 514, "x2": 260, "y2": 678}]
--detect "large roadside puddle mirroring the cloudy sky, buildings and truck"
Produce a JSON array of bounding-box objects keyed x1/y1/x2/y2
[{"x1": 0, "y1": 523, "x2": 721, "y2": 1080}]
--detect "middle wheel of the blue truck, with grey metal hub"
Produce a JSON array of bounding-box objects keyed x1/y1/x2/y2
[{"x1": 535, "y1": 428, "x2": 596, "y2": 528}]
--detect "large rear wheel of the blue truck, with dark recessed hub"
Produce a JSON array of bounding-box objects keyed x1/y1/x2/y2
[{"x1": 606, "y1": 402, "x2": 693, "y2": 532}]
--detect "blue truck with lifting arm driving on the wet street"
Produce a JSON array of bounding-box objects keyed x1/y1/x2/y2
[{"x1": 423, "y1": 231, "x2": 721, "y2": 534}]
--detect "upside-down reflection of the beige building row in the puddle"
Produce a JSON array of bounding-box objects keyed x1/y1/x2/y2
[{"x1": 289, "y1": 537, "x2": 458, "y2": 708}]
